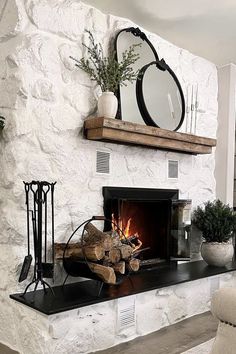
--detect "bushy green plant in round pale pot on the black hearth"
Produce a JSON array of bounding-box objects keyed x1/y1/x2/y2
[{"x1": 192, "y1": 199, "x2": 236, "y2": 267}]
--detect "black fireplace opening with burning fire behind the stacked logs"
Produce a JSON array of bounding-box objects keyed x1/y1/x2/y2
[{"x1": 103, "y1": 187, "x2": 191, "y2": 266}]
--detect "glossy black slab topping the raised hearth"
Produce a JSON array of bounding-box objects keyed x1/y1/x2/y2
[{"x1": 10, "y1": 261, "x2": 236, "y2": 315}]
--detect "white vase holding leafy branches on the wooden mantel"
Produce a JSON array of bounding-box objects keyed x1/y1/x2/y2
[{"x1": 98, "y1": 91, "x2": 118, "y2": 118}]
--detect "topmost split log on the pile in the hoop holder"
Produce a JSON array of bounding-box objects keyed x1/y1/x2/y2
[{"x1": 84, "y1": 223, "x2": 113, "y2": 251}]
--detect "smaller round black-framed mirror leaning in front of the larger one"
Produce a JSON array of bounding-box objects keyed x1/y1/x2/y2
[{"x1": 136, "y1": 60, "x2": 185, "y2": 131}]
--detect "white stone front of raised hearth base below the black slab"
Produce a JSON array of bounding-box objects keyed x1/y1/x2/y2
[{"x1": 6, "y1": 272, "x2": 236, "y2": 354}]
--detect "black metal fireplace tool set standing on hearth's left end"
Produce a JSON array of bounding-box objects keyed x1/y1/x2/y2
[{"x1": 19, "y1": 181, "x2": 56, "y2": 296}]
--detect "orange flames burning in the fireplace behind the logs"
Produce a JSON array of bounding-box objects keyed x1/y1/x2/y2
[{"x1": 112, "y1": 214, "x2": 142, "y2": 252}]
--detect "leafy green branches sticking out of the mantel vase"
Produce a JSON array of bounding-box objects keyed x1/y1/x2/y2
[{"x1": 70, "y1": 31, "x2": 141, "y2": 92}]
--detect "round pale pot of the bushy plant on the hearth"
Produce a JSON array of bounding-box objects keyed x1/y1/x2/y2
[{"x1": 201, "y1": 242, "x2": 234, "y2": 267}]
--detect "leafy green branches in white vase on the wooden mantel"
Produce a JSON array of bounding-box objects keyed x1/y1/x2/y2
[{"x1": 70, "y1": 31, "x2": 141, "y2": 118}]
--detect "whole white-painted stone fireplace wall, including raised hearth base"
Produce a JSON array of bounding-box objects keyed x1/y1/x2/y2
[{"x1": 0, "y1": 0, "x2": 217, "y2": 354}]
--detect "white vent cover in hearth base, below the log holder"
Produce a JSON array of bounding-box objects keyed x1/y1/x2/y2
[{"x1": 117, "y1": 296, "x2": 136, "y2": 332}]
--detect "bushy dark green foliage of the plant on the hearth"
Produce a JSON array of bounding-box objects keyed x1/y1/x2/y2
[{"x1": 192, "y1": 199, "x2": 236, "y2": 242}]
